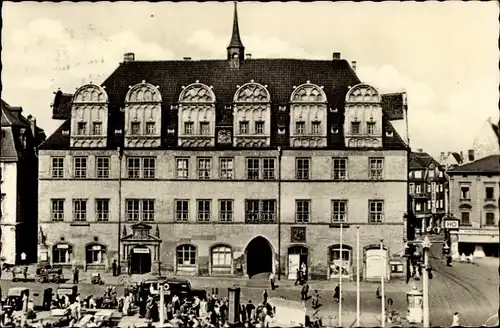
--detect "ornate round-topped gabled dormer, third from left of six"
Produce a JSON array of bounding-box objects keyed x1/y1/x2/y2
[{"x1": 178, "y1": 81, "x2": 216, "y2": 147}]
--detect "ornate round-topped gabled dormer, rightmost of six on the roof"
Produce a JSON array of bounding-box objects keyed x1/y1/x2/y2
[{"x1": 344, "y1": 83, "x2": 383, "y2": 148}]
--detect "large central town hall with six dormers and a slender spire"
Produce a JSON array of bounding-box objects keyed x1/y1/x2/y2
[{"x1": 39, "y1": 2, "x2": 408, "y2": 279}]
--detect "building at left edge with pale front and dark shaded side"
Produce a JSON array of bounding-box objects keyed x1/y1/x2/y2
[{"x1": 0, "y1": 100, "x2": 45, "y2": 264}]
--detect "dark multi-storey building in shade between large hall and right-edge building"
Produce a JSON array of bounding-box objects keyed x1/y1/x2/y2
[{"x1": 409, "y1": 149, "x2": 448, "y2": 232}]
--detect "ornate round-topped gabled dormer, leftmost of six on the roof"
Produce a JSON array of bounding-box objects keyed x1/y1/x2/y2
[{"x1": 70, "y1": 83, "x2": 108, "y2": 148}]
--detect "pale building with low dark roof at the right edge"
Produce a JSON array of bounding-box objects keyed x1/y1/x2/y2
[{"x1": 448, "y1": 155, "x2": 500, "y2": 258}]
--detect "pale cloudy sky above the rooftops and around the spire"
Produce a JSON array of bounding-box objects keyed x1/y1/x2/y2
[{"x1": 1, "y1": 1, "x2": 499, "y2": 156}]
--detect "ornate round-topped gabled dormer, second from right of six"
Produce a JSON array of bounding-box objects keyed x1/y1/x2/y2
[{"x1": 290, "y1": 81, "x2": 327, "y2": 148}]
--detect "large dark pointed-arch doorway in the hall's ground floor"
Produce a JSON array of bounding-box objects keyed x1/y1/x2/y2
[{"x1": 246, "y1": 236, "x2": 273, "y2": 277}]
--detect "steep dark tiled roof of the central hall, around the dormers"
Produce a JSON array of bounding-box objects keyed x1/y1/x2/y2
[{"x1": 43, "y1": 59, "x2": 406, "y2": 149}]
